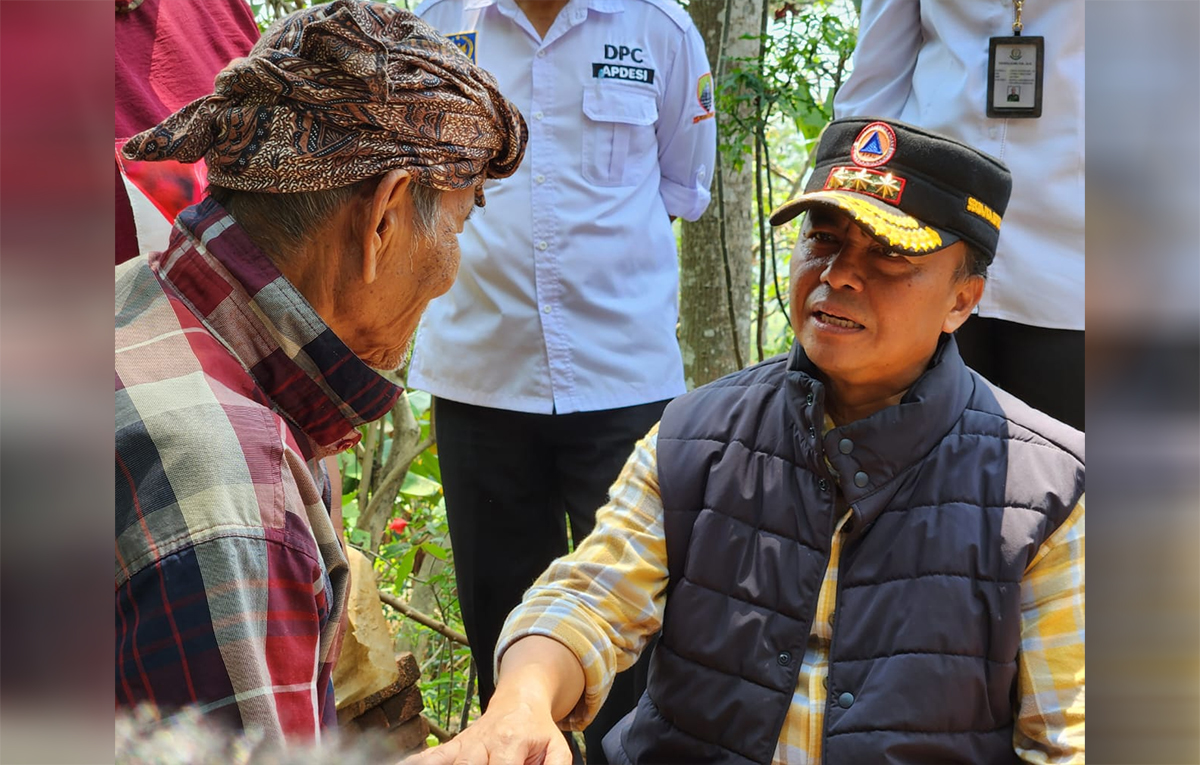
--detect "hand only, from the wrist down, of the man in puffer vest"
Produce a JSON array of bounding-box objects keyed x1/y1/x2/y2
[{"x1": 404, "y1": 697, "x2": 571, "y2": 765}]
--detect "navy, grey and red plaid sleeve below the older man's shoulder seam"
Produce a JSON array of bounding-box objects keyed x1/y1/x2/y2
[{"x1": 116, "y1": 534, "x2": 329, "y2": 741}]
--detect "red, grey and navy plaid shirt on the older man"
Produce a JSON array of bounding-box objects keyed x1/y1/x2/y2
[{"x1": 115, "y1": 199, "x2": 400, "y2": 740}]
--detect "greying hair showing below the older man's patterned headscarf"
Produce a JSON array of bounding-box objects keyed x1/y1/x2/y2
[{"x1": 208, "y1": 176, "x2": 443, "y2": 260}]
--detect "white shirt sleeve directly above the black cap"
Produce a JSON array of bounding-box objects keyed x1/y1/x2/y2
[{"x1": 833, "y1": 0, "x2": 916, "y2": 119}]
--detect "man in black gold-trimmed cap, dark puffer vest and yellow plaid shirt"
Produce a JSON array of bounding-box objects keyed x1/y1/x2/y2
[{"x1": 421, "y1": 119, "x2": 1084, "y2": 765}]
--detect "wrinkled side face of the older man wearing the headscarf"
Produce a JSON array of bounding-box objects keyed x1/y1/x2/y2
[{"x1": 352, "y1": 187, "x2": 475, "y2": 371}]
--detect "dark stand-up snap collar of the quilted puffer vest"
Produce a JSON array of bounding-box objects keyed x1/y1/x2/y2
[{"x1": 787, "y1": 335, "x2": 973, "y2": 529}]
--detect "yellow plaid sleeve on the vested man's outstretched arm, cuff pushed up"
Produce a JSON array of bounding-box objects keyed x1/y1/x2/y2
[{"x1": 496, "y1": 426, "x2": 667, "y2": 730}]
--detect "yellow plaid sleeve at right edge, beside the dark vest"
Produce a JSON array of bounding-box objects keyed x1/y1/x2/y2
[{"x1": 1013, "y1": 498, "x2": 1085, "y2": 764}]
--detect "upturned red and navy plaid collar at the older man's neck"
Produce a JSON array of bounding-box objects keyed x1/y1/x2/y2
[{"x1": 150, "y1": 198, "x2": 401, "y2": 457}]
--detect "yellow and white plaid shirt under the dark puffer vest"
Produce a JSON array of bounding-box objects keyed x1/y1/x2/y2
[{"x1": 496, "y1": 423, "x2": 1084, "y2": 765}]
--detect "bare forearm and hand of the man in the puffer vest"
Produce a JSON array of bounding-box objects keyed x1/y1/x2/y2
[{"x1": 404, "y1": 636, "x2": 583, "y2": 765}]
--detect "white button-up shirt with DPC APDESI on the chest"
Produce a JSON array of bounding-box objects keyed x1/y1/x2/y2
[{"x1": 408, "y1": 0, "x2": 716, "y2": 414}]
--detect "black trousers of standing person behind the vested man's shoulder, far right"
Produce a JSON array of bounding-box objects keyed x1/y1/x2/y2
[{"x1": 955, "y1": 315, "x2": 1084, "y2": 430}]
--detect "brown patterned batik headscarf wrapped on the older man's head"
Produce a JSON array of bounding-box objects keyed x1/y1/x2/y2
[{"x1": 121, "y1": 0, "x2": 529, "y2": 197}]
